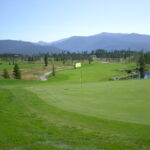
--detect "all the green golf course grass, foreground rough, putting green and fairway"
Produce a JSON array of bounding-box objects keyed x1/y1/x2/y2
[{"x1": 0, "y1": 62, "x2": 150, "y2": 150}]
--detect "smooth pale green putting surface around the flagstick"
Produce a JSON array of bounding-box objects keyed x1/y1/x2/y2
[{"x1": 28, "y1": 80, "x2": 150, "y2": 124}]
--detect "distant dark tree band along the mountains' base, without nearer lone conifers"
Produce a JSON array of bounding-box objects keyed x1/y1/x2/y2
[{"x1": 0, "y1": 49, "x2": 150, "y2": 65}]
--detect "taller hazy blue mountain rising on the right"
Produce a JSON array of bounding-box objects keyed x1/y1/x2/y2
[{"x1": 47, "y1": 33, "x2": 150, "y2": 51}]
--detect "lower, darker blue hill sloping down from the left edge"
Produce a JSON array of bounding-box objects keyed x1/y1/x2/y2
[{"x1": 0, "y1": 40, "x2": 62, "y2": 55}]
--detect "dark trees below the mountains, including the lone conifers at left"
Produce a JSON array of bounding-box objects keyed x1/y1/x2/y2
[{"x1": 0, "y1": 49, "x2": 150, "y2": 79}]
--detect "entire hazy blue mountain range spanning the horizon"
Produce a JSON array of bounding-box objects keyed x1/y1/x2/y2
[{"x1": 0, "y1": 32, "x2": 150, "y2": 55}]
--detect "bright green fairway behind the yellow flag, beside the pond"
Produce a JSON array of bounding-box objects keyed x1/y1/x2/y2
[{"x1": 49, "y1": 63, "x2": 135, "y2": 83}]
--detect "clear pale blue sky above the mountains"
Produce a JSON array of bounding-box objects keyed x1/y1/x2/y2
[{"x1": 0, "y1": 0, "x2": 150, "y2": 42}]
